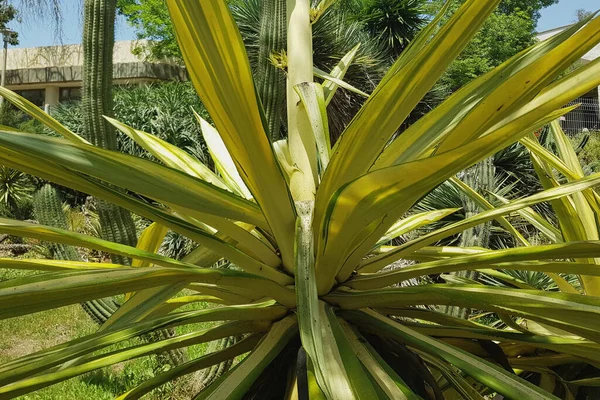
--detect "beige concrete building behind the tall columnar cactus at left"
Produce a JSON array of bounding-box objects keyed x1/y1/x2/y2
[{"x1": 6, "y1": 41, "x2": 187, "y2": 110}]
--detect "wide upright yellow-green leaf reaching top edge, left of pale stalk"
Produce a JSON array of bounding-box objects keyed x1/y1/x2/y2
[{"x1": 167, "y1": 0, "x2": 295, "y2": 270}]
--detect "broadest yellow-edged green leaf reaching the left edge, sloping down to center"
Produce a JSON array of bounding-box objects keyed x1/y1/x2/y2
[{"x1": 0, "y1": 132, "x2": 265, "y2": 227}]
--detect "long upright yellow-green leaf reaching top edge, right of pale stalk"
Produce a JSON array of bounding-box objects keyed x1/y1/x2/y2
[{"x1": 315, "y1": 0, "x2": 499, "y2": 230}]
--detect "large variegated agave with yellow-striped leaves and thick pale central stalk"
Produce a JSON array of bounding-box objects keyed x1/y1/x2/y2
[{"x1": 0, "y1": 0, "x2": 600, "y2": 400}]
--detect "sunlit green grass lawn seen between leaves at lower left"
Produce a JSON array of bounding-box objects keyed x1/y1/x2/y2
[{"x1": 0, "y1": 270, "x2": 216, "y2": 400}]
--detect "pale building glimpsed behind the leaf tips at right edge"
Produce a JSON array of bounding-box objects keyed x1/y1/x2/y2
[{"x1": 537, "y1": 25, "x2": 600, "y2": 134}]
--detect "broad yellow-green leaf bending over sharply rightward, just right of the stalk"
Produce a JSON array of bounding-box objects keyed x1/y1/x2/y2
[{"x1": 317, "y1": 109, "x2": 567, "y2": 294}]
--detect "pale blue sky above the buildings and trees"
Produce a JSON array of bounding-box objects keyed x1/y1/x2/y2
[{"x1": 10, "y1": 0, "x2": 600, "y2": 47}]
